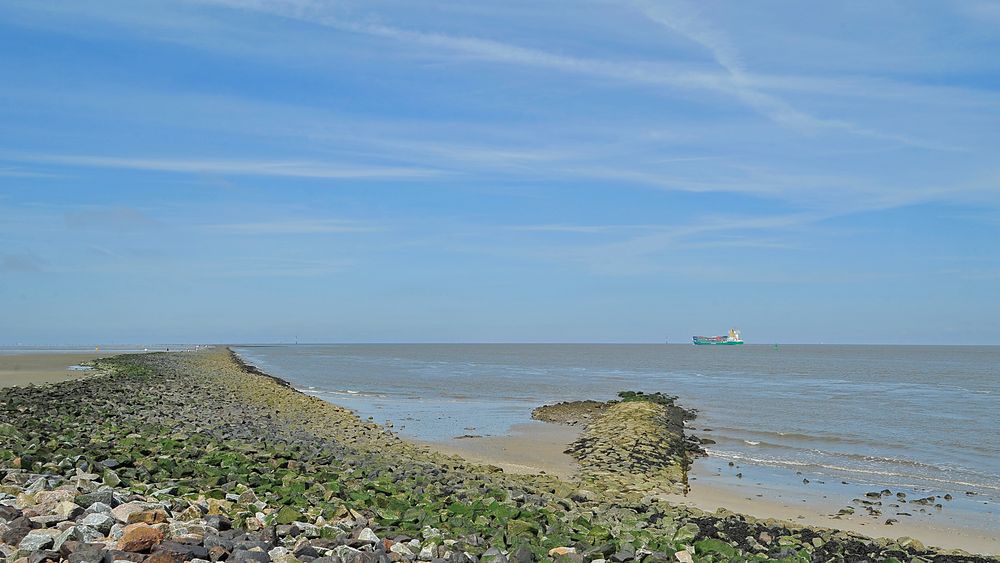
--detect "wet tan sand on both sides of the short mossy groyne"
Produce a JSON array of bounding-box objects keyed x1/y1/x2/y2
[{"x1": 424, "y1": 422, "x2": 1000, "y2": 555}]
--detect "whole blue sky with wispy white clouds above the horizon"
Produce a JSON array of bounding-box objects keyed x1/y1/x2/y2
[{"x1": 0, "y1": 0, "x2": 1000, "y2": 345}]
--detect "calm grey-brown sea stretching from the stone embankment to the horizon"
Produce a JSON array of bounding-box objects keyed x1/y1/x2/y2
[{"x1": 236, "y1": 344, "x2": 1000, "y2": 515}]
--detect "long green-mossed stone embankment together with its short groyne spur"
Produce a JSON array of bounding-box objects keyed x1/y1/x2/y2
[{"x1": 0, "y1": 348, "x2": 996, "y2": 563}]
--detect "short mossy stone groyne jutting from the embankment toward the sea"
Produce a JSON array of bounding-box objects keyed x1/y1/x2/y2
[{"x1": 532, "y1": 391, "x2": 705, "y2": 496}]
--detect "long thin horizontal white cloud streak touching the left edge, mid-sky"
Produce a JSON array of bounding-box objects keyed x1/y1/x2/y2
[{"x1": 0, "y1": 153, "x2": 442, "y2": 180}]
